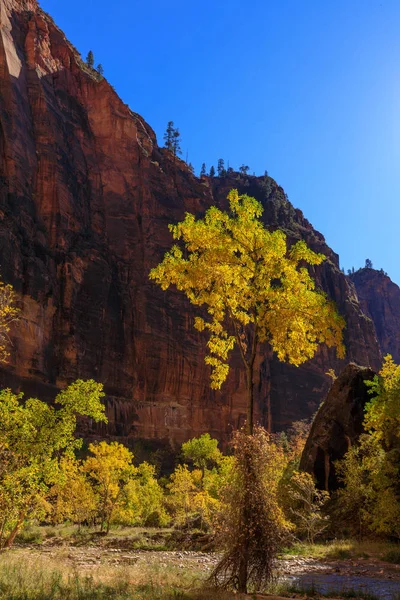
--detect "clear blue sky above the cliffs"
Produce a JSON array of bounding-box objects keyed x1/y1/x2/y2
[{"x1": 41, "y1": 0, "x2": 400, "y2": 284}]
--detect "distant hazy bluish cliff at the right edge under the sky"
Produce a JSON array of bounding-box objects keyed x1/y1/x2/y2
[{"x1": 350, "y1": 269, "x2": 400, "y2": 363}]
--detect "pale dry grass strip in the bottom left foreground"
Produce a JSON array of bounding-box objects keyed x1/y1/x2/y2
[{"x1": 0, "y1": 548, "x2": 232, "y2": 600}]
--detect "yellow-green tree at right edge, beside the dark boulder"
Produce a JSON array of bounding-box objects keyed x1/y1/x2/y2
[{"x1": 336, "y1": 355, "x2": 400, "y2": 538}]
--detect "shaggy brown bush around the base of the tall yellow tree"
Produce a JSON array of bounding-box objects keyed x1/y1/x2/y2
[{"x1": 210, "y1": 428, "x2": 287, "y2": 593}]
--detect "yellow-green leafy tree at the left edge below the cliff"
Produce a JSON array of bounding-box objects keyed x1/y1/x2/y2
[{"x1": 0, "y1": 380, "x2": 107, "y2": 547}]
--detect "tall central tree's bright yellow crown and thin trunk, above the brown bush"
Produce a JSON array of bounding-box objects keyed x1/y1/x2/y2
[{"x1": 150, "y1": 190, "x2": 344, "y2": 434}]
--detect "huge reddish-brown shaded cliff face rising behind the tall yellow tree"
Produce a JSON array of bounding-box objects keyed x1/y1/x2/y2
[{"x1": 0, "y1": 0, "x2": 380, "y2": 442}]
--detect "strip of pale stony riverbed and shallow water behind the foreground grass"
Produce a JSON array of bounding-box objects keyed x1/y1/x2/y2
[{"x1": 8, "y1": 540, "x2": 400, "y2": 600}]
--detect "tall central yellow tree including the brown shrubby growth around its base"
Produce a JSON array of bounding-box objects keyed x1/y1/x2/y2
[{"x1": 150, "y1": 190, "x2": 344, "y2": 592}]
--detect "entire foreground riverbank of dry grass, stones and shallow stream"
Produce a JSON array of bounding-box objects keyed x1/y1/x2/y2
[{"x1": 0, "y1": 530, "x2": 400, "y2": 600}]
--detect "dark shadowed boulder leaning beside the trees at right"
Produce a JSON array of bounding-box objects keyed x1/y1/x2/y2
[{"x1": 300, "y1": 364, "x2": 375, "y2": 490}]
